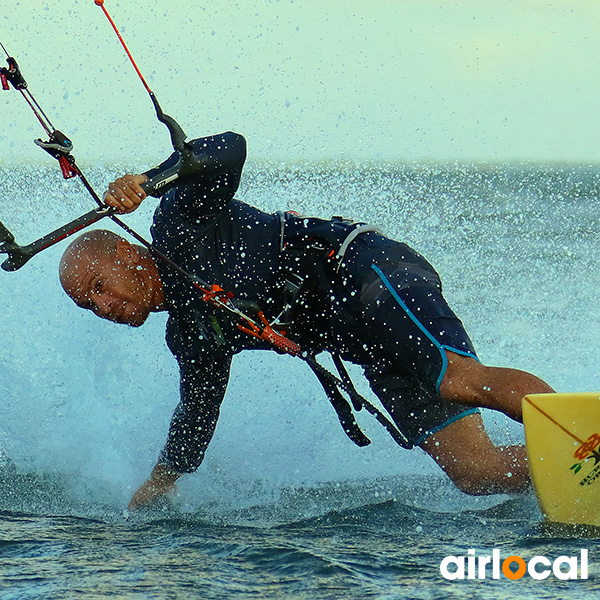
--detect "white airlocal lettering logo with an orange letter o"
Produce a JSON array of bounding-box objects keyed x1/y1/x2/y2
[{"x1": 440, "y1": 549, "x2": 588, "y2": 580}]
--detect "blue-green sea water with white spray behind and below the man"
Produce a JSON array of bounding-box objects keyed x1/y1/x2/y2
[{"x1": 0, "y1": 163, "x2": 600, "y2": 600}]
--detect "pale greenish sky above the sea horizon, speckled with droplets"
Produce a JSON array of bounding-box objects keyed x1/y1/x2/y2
[{"x1": 0, "y1": 0, "x2": 600, "y2": 168}]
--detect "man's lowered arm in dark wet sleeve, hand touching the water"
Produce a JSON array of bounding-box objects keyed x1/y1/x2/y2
[{"x1": 129, "y1": 353, "x2": 231, "y2": 510}]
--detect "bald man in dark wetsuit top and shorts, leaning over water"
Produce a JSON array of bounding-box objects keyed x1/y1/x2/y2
[{"x1": 60, "y1": 132, "x2": 552, "y2": 509}]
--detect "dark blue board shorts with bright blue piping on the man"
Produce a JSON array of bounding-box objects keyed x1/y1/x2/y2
[{"x1": 343, "y1": 232, "x2": 479, "y2": 446}]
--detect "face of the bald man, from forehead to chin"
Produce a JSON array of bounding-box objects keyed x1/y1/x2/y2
[{"x1": 65, "y1": 256, "x2": 152, "y2": 327}]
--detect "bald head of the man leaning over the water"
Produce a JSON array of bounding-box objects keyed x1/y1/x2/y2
[{"x1": 59, "y1": 229, "x2": 163, "y2": 326}]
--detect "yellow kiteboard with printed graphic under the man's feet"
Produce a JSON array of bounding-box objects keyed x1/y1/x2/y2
[{"x1": 523, "y1": 393, "x2": 600, "y2": 526}]
